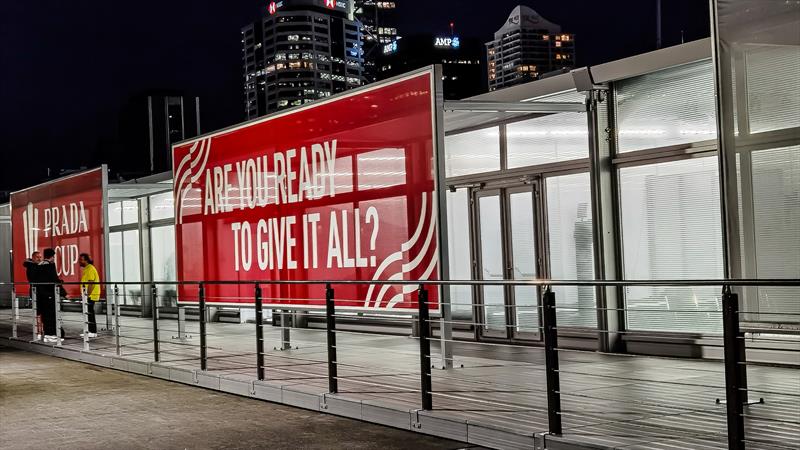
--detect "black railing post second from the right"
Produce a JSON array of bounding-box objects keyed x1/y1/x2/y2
[{"x1": 542, "y1": 287, "x2": 562, "y2": 435}]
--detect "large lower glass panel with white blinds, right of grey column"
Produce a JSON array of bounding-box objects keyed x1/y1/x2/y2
[{"x1": 619, "y1": 156, "x2": 722, "y2": 333}]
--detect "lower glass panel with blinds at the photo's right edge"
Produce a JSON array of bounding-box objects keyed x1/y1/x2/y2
[{"x1": 751, "y1": 145, "x2": 800, "y2": 322}]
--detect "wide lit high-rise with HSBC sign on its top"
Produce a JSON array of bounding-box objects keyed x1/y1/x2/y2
[{"x1": 242, "y1": 0, "x2": 364, "y2": 120}]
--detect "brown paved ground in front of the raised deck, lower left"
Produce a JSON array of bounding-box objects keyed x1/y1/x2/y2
[{"x1": 0, "y1": 347, "x2": 465, "y2": 449}]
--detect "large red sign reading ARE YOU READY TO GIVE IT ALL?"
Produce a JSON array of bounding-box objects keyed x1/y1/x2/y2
[{"x1": 173, "y1": 71, "x2": 439, "y2": 311}]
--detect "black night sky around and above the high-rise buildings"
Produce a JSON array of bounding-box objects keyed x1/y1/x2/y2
[{"x1": 0, "y1": 0, "x2": 708, "y2": 195}]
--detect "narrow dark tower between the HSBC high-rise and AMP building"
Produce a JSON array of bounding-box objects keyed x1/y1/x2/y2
[{"x1": 353, "y1": 0, "x2": 400, "y2": 82}]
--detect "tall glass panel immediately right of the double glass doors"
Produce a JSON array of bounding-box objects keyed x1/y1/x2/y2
[{"x1": 545, "y1": 173, "x2": 597, "y2": 328}]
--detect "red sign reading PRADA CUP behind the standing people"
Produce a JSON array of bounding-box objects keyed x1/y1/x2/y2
[{"x1": 11, "y1": 169, "x2": 105, "y2": 297}]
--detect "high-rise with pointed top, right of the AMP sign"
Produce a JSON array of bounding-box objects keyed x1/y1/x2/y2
[{"x1": 486, "y1": 5, "x2": 575, "y2": 91}]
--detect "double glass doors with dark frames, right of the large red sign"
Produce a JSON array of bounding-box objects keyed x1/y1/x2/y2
[{"x1": 473, "y1": 181, "x2": 541, "y2": 339}]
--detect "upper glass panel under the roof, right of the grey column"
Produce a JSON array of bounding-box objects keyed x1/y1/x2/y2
[{"x1": 616, "y1": 60, "x2": 717, "y2": 152}]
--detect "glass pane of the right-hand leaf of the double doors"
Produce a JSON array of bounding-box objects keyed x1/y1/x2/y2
[{"x1": 508, "y1": 191, "x2": 539, "y2": 333}]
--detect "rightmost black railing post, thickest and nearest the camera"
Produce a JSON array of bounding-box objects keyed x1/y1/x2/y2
[{"x1": 722, "y1": 286, "x2": 744, "y2": 449}]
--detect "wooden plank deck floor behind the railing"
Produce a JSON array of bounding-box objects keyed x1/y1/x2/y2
[{"x1": 0, "y1": 310, "x2": 800, "y2": 449}]
